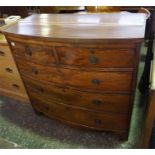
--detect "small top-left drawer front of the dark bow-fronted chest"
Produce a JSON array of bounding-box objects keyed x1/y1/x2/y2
[{"x1": 11, "y1": 42, "x2": 55, "y2": 65}]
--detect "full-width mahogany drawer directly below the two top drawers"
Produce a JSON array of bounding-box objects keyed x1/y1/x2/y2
[{"x1": 16, "y1": 57, "x2": 132, "y2": 92}]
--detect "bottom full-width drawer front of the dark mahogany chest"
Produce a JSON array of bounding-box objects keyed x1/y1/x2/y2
[{"x1": 31, "y1": 97, "x2": 128, "y2": 131}]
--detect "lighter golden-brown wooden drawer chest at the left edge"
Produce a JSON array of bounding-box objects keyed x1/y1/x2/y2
[{"x1": 0, "y1": 34, "x2": 29, "y2": 103}]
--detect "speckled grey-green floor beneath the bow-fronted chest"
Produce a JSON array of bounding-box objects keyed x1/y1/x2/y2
[{"x1": 0, "y1": 44, "x2": 146, "y2": 149}]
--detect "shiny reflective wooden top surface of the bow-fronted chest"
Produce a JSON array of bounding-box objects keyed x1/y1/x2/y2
[{"x1": 5, "y1": 12, "x2": 146, "y2": 39}]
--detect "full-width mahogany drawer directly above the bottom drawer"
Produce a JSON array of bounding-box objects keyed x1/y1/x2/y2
[{"x1": 25, "y1": 78, "x2": 130, "y2": 114}]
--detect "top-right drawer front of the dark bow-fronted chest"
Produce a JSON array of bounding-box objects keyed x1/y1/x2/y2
[{"x1": 56, "y1": 47, "x2": 135, "y2": 68}]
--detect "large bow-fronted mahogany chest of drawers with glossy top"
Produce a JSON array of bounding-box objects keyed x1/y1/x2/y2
[{"x1": 4, "y1": 13, "x2": 146, "y2": 138}]
